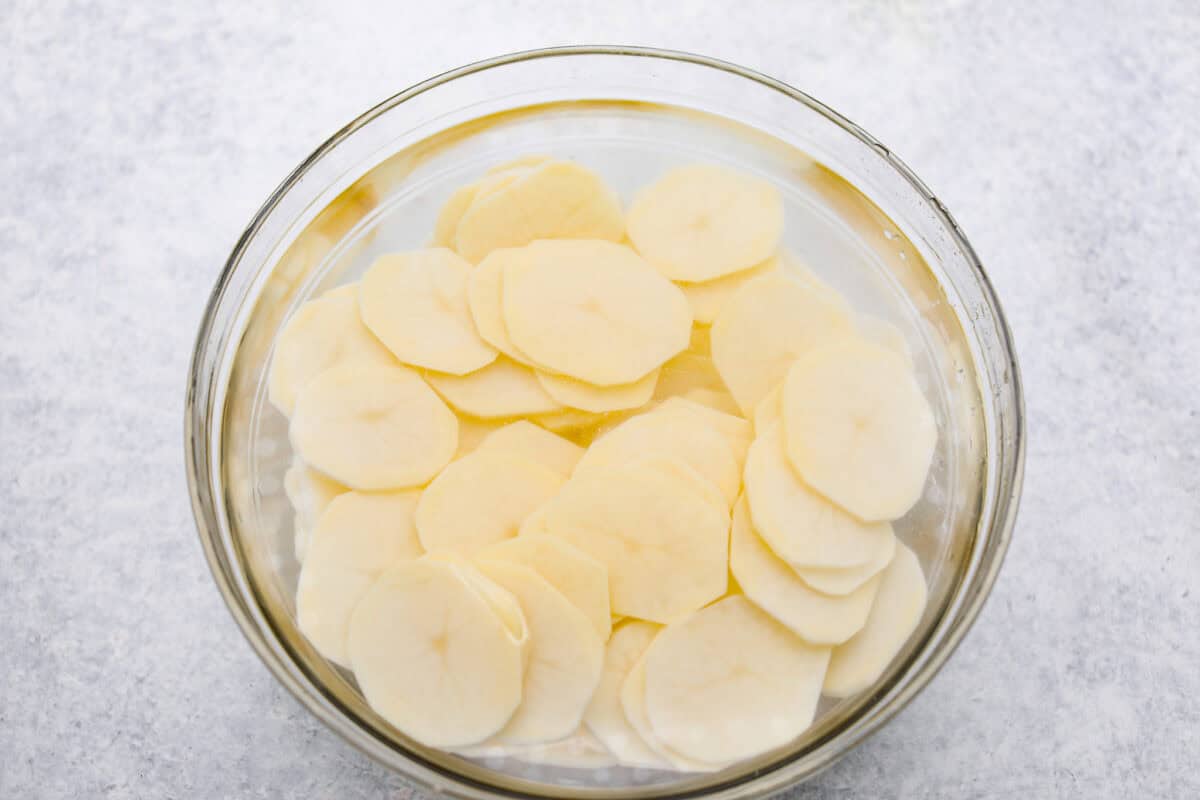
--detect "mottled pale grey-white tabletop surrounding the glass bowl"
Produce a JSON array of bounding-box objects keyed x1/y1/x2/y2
[{"x1": 0, "y1": 0, "x2": 1200, "y2": 800}]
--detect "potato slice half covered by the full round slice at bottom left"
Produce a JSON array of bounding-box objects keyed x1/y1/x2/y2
[{"x1": 296, "y1": 491, "x2": 424, "y2": 666}]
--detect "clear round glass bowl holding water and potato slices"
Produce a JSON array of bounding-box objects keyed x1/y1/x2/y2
[{"x1": 185, "y1": 47, "x2": 1024, "y2": 798}]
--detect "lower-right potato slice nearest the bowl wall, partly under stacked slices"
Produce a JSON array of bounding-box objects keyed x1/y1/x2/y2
[{"x1": 823, "y1": 545, "x2": 926, "y2": 698}]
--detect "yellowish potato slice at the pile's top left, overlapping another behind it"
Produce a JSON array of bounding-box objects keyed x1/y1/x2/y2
[{"x1": 455, "y1": 160, "x2": 625, "y2": 263}]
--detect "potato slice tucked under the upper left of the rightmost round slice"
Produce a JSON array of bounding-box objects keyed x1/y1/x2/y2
[{"x1": 712, "y1": 271, "x2": 853, "y2": 415}]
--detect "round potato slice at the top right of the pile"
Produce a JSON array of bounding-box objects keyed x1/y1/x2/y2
[{"x1": 629, "y1": 164, "x2": 784, "y2": 282}]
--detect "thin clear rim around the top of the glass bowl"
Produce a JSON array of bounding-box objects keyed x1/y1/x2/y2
[{"x1": 184, "y1": 46, "x2": 1025, "y2": 799}]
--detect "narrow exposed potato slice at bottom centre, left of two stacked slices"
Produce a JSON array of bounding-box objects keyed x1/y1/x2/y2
[{"x1": 583, "y1": 620, "x2": 667, "y2": 769}]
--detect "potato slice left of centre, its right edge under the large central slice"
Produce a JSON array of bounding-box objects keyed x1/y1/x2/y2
[{"x1": 416, "y1": 450, "x2": 563, "y2": 553}]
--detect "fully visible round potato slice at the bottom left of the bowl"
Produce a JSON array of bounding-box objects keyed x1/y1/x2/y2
[{"x1": 349, "y1": 558, "x2": 527, "y2": 747}]
